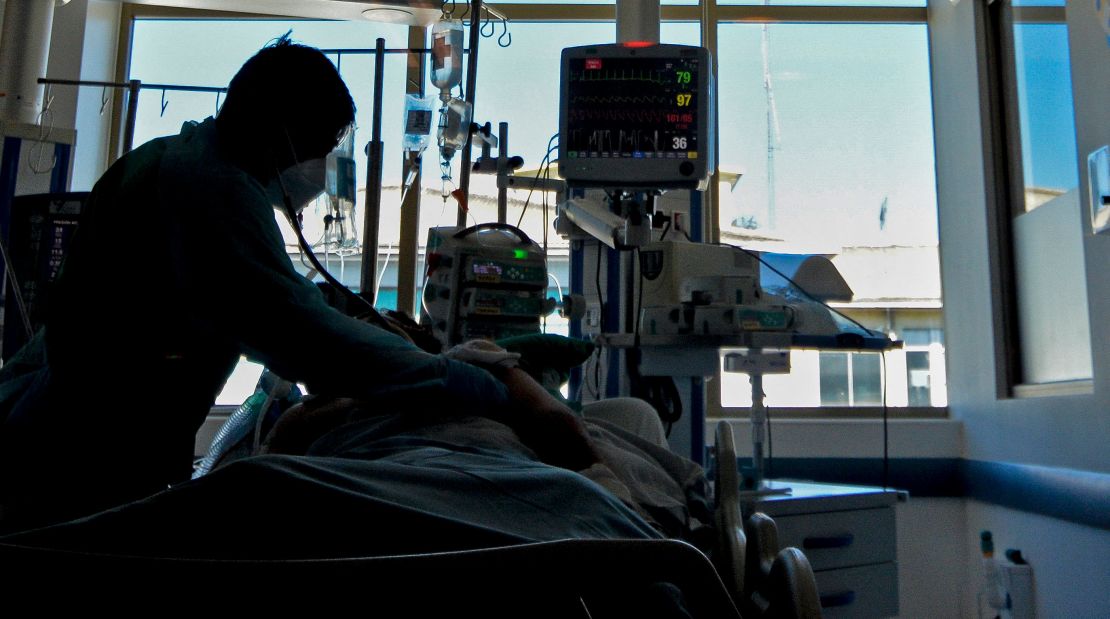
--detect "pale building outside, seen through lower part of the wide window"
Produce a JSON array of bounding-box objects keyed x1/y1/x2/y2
[{"x1": 291, "y1": 181, "x2": 948, "y2": 407}]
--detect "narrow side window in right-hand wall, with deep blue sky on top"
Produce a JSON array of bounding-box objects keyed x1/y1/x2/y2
[{"x1": 988, "y1": 0, "x2": 1092, "y2": 396}]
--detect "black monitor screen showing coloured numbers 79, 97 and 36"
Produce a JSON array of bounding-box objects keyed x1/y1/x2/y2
[{"x1": 562, "y1": 57, "x2": 702, "y2": 160}]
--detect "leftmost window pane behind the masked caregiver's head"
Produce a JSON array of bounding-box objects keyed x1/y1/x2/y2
[{"x1": 128, "y1": 19, "x2": 407, "y2": 405}]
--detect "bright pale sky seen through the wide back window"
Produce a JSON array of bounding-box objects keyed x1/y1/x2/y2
[{"x1": 131, "y1": 21, "x2": 936, "y2": 251}]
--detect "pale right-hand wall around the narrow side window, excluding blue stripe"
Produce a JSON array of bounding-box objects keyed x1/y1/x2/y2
[{"x1": 929, "y1": 0, "x2": 1110, "y2": 618}]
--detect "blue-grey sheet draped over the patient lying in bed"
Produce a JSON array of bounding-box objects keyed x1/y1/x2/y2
[{"x1": 6, "y1": 335, "x2": 712, "y2": 559}]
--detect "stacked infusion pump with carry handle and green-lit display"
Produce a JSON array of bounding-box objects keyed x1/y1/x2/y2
[{"x1": 421, "y1": 223, "x2": 555, "y2": 346}]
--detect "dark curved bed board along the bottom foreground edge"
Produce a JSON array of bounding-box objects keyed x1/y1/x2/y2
[{"x1": 0, "y1": 540, "x2": 738, "y2": 618}]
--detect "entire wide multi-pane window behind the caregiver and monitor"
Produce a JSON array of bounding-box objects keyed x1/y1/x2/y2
[{"x1": 119, "y1": 0, "x2": 946, "y2": 413}]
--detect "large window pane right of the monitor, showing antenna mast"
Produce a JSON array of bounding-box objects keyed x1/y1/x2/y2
[{"x1": 718, "y1": 23, "x2": 947, "y2": 414}]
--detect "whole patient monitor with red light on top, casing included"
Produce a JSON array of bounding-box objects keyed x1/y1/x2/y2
[{"x1": 559, "y1": 45, "x2": 712, "y2": 187}]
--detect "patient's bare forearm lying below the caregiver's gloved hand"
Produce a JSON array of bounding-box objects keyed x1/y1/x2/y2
[{"x1": 498, "y1": 367, "x2": 601, "y2": 470}]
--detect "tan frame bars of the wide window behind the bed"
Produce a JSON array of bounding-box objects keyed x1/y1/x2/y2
[{"x1": 107, "y1": 0, "x2": 948, "y2": 423}]
